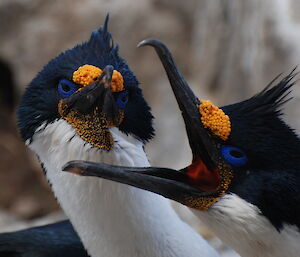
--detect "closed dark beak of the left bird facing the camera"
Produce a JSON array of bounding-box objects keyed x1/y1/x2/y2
[{"x1": 59, "y1": 65, "x2": 119, "y2": 122}]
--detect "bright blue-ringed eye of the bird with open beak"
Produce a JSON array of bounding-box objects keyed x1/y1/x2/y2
[{"x1": 221, "y1": 145, "x2": 248, "y2": 167}]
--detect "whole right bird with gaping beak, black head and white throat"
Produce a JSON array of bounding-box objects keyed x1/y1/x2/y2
[{"x1": 64, "y1": 39, "x2": 300, "y2": 257}]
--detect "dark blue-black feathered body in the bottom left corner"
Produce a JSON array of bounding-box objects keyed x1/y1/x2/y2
[{"x1": 0, "y1": 221, "x2": 89, "y2": 257}]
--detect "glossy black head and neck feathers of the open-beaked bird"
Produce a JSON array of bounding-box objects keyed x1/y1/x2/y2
[{"x1": 221, "y1": 70, "x2": 300, "y2": 230}]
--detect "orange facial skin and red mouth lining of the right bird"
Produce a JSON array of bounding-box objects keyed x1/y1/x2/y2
[{"x1": 183, "y1": 100, "x2": 233, "y2": 211}]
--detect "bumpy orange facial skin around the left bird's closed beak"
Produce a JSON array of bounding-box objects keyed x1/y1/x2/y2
[{"x1": 58, "y1": 65, "x2": 124, "y2": 151}]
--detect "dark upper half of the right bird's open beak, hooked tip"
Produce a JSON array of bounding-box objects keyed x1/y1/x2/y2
[{"x1": 138, "y1": 39, "x2": 218, "y2": 166}]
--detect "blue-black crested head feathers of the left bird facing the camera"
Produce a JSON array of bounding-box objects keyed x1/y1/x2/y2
[{"x1": 17, "y1": 15, "x2": 154, "y2": 142}]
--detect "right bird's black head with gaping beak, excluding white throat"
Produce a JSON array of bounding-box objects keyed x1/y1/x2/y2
[{"x1": 65, "y1": 39, "x2": 300, "y2": 228}]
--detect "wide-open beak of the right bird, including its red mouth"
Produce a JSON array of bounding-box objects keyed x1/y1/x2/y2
[{"x1": 63, "y1": 39, "x2": 232, "y2": 210}]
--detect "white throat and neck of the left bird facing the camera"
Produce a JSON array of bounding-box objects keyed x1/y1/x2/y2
[{"x1": 28, "y1": 120, "x2": 217, "y2": 257}]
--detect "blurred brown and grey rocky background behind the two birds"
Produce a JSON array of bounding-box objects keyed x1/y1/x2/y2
[{"x1": 0, "y1": 0, "x2": 300, "y2": 256}]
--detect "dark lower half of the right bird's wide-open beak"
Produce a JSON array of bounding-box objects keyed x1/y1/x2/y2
[{"x1": 62, "y1": 161, "x2": 218, "y2": 204}]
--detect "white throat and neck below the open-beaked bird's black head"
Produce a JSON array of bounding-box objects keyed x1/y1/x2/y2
[{"x1": 193, "y1": 194, "x2": 300, "y2": 257}]
